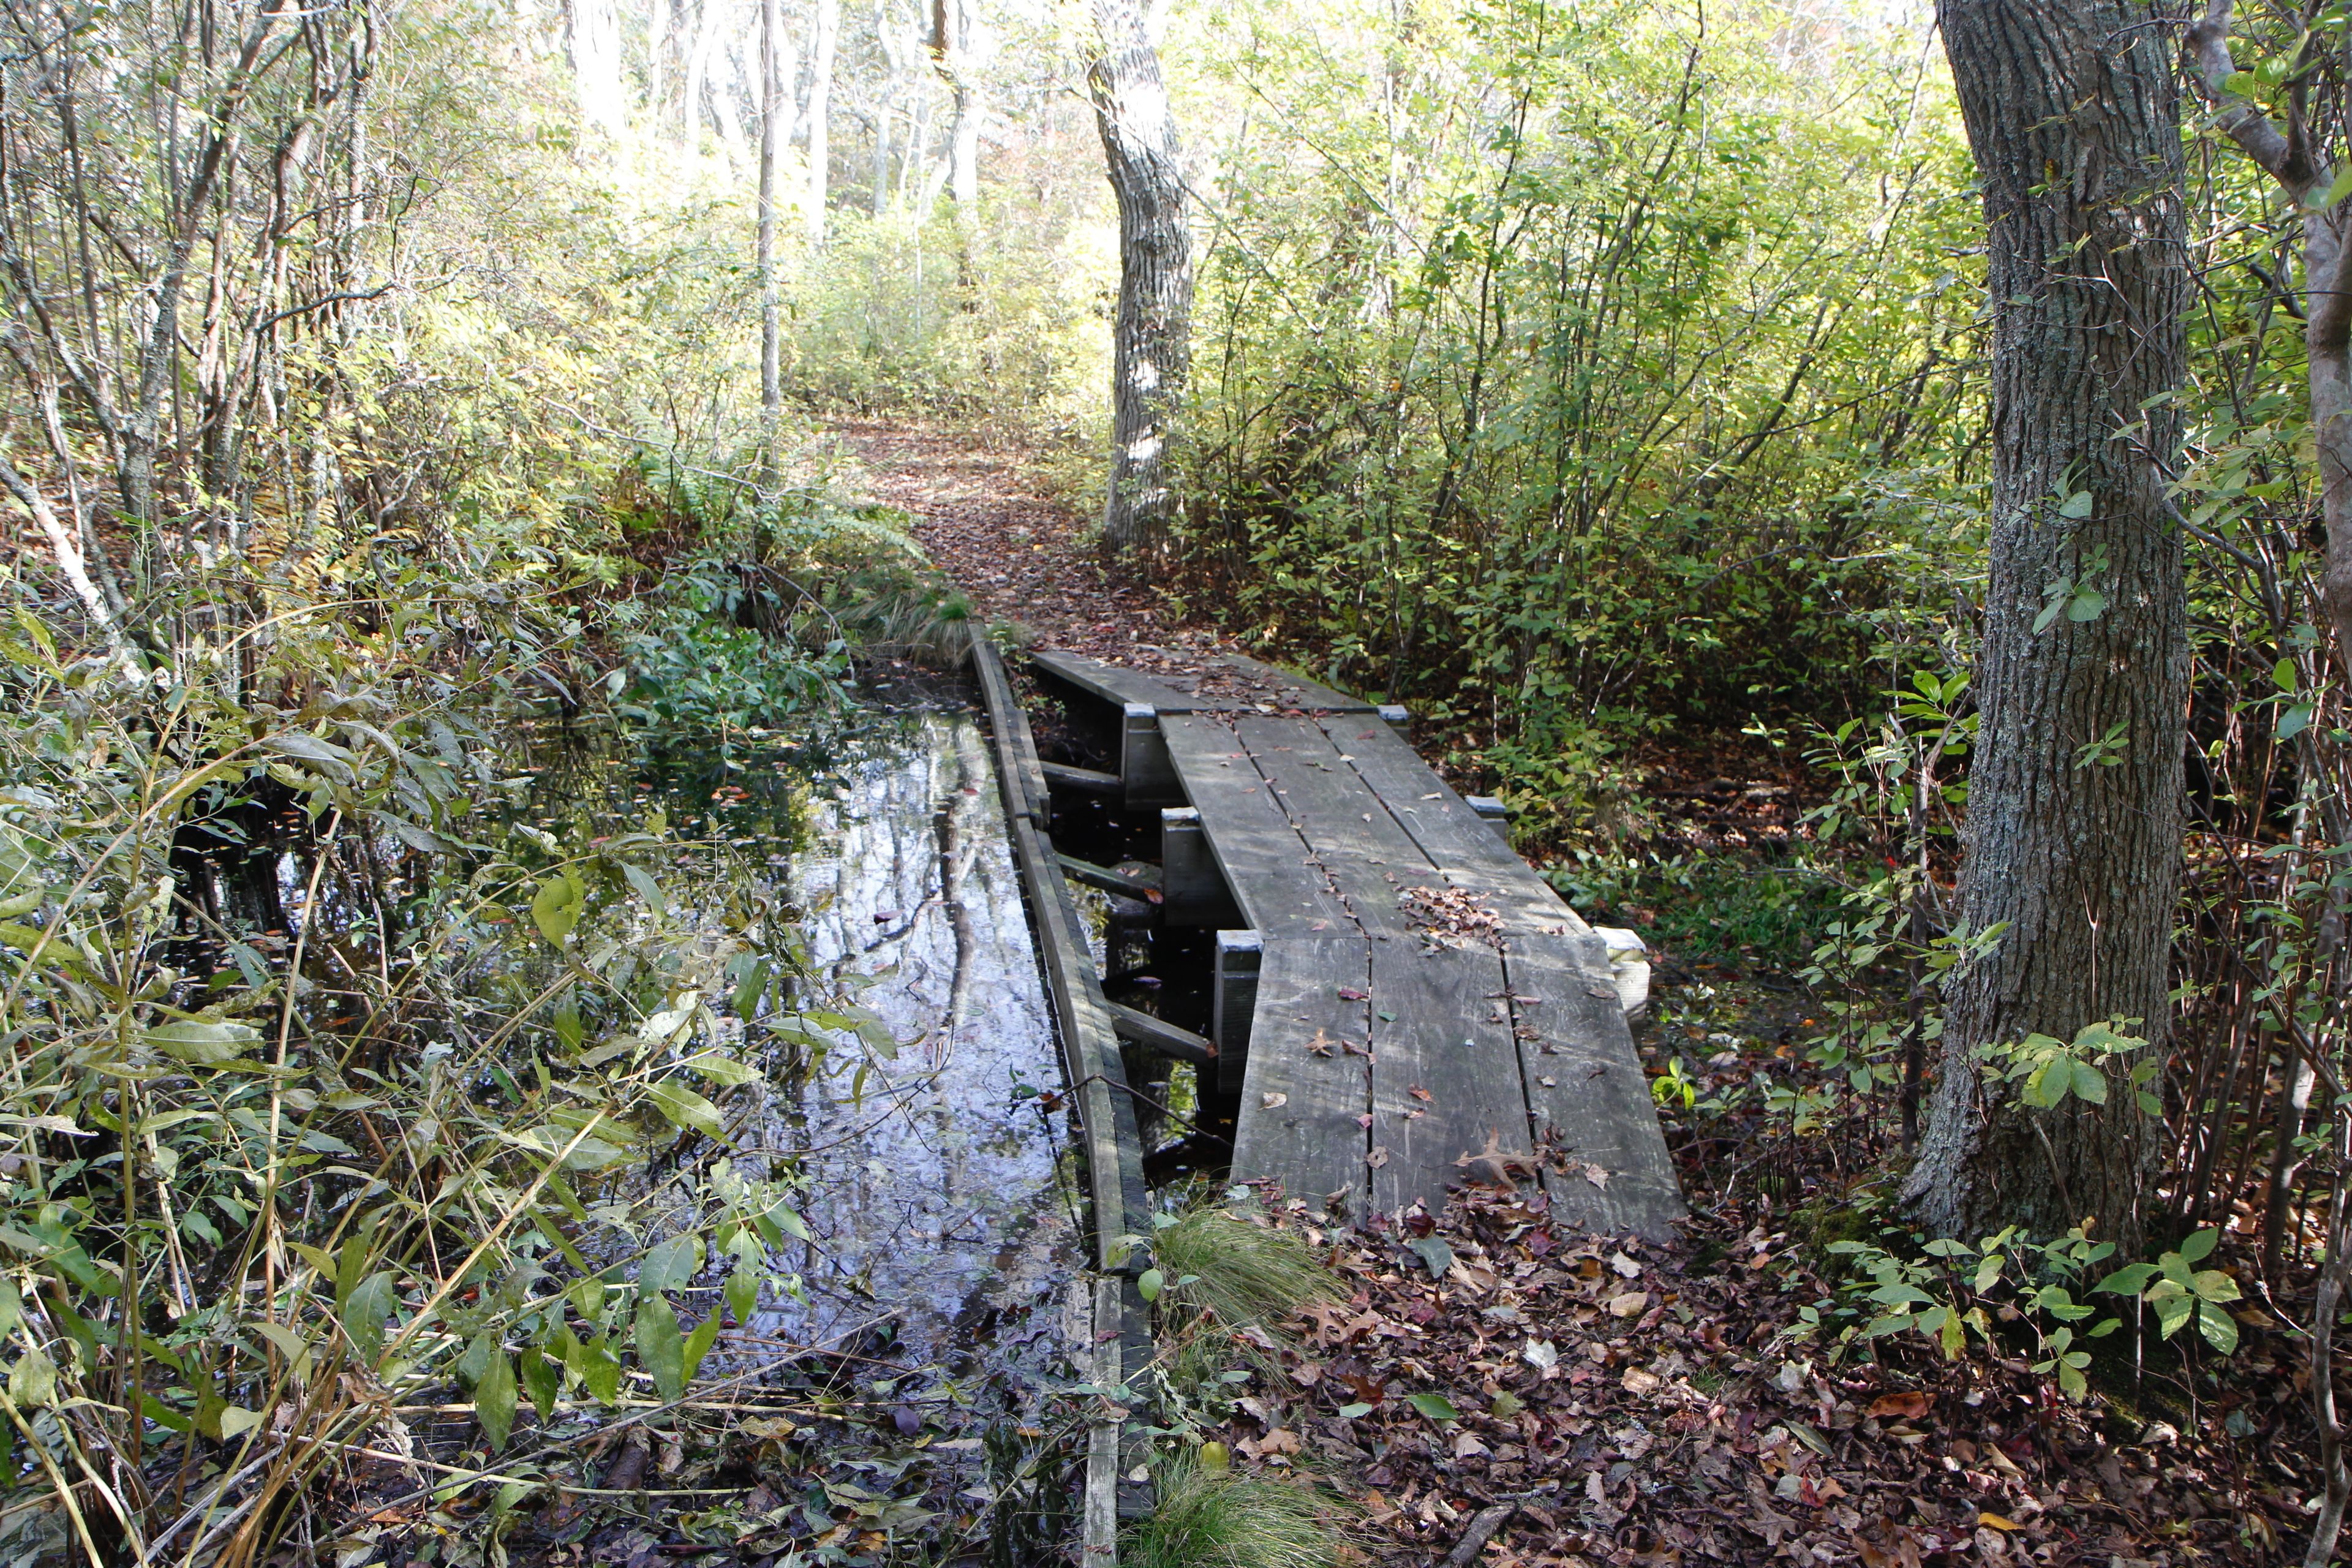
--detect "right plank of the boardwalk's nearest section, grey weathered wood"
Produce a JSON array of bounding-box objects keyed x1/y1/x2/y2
[{"x1": 1503, "y1": 933, "x2": 1684, "y2": 1237}]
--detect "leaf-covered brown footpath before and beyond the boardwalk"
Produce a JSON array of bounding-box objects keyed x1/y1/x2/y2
[{"x1": 835, "y1": 423, "x2": 2310, "y2": 1568}]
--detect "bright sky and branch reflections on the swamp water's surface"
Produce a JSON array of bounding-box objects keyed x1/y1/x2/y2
[{"x1": 762, "y1": 715, "x2": 1068, "y2": 1357}]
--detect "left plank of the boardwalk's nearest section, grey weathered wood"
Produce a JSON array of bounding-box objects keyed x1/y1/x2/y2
[{"x1": 1232, "y1": 931, "x2": 1371, "y2": 1220}]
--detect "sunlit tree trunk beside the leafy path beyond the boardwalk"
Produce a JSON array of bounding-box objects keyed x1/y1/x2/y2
[{"x1": 1087, "y1": 0, "x2": 1193, "y2": 557}]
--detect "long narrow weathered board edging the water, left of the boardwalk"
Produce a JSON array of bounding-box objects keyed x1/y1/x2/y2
[{"x1": 971, "y1": 639, "x2": 1155, "y2": 1542}]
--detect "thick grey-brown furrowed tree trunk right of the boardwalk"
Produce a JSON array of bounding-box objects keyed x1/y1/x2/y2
[{"x1": 1905, "y1": 0, "x2": 2190, "y2": 1256}]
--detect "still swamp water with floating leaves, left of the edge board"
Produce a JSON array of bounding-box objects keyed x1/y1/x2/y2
[{"x1": 412, "y1": 705, "x2": 1082, "y2": 1568}]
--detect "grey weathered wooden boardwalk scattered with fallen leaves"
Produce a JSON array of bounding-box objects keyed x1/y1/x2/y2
[{"x1": 1030, "y1": 651, "x2": 1684, "y2": 1234}]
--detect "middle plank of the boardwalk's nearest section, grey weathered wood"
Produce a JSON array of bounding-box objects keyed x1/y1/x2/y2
[{"x1": 1369, "y1": 943, "x2": 1531, "y2": 1213}]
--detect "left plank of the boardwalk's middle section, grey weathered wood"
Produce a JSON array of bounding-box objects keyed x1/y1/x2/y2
[{"x1": 1162, "y1": 715, "x2": 1350, "y2": 933}]
